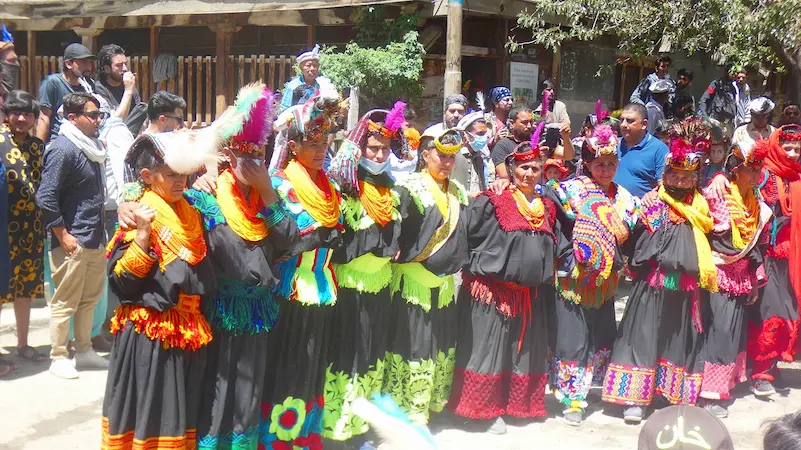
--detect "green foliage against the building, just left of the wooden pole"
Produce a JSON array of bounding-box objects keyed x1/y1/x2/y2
[{"x1": 320, "y1": 31, "x2": 425, "y2": 107}]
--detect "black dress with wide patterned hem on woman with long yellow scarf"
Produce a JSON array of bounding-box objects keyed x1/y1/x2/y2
[{"x1": 602, "y1": 200, "x2": 706, "y2": 406}]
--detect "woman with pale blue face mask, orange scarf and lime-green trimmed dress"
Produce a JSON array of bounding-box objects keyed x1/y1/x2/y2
[{"x1": 323, "y1": 107, "x2": 406, "y2": 448}]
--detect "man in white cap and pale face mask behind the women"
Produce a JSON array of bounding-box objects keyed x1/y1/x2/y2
[{"x1": 451, "y1": 112, "x2": 495, "y2": 197}]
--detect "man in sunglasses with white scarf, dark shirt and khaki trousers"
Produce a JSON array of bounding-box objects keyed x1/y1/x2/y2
[{"x1": 36, "y1": 92, "x2": 108, "y2": 379}]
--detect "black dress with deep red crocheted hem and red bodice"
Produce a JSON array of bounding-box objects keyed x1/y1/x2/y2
[{"x1": 448, "y1": 190, "x2": 556, "y2": 419}]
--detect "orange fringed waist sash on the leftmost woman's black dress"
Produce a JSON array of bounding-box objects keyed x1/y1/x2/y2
[{"x1": 111, "y1": 293, "x2": 212, "y2": 350}]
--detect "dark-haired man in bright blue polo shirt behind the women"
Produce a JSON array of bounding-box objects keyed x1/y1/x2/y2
[{"x1": 615, "y1": 103, "x2": 668, "y2": 198}]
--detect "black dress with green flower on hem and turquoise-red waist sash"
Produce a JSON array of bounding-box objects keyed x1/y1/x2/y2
[{"x1": 259, "y1": 169, "x2": 343, "y2": 449}]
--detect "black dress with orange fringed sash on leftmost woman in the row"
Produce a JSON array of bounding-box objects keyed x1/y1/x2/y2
[{"x1": 101, "y1": 194, "x2": 216, "y2": 450}]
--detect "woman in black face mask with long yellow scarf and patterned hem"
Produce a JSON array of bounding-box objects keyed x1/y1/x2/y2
[{"x1": 601, "y1": 135, "x2": 718, "y2": 422}]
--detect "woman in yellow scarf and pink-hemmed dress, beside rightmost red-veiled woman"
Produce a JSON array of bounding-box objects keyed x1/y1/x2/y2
[{"x1": 700, "y1": 140, "x2": 772, "y2": 418}]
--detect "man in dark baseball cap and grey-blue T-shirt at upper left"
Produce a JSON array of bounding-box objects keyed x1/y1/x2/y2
[{"x1": 36, "y1": 43, "x2": 95, "y2": 144}]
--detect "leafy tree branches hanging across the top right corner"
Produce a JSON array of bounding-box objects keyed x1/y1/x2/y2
[{"x1": 508, "y1": 0, "x2": 801, "y2": 100}]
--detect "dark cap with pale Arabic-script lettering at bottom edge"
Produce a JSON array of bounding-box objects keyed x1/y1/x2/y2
[{"x1": 637, "y1": 405, "x2": 734, "y2": 450}]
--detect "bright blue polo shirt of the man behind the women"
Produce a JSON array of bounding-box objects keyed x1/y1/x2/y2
[{"x1": 614, "y1": 133, "x2": 669, "y2": 198}]
